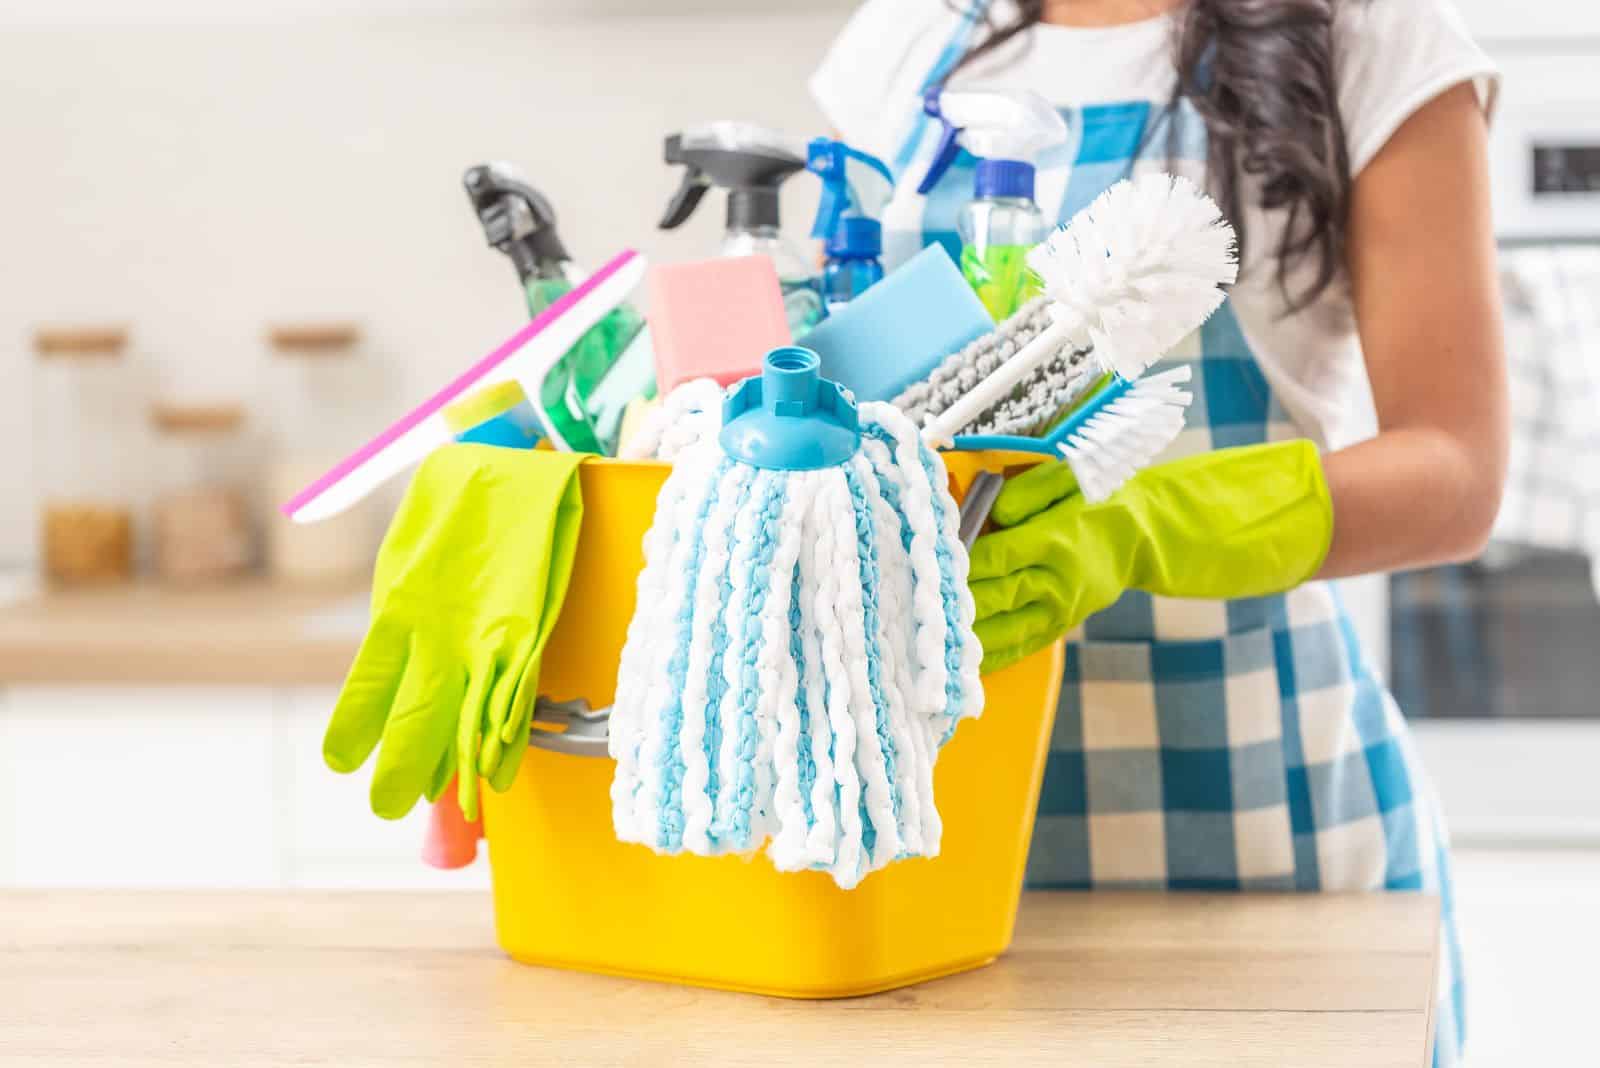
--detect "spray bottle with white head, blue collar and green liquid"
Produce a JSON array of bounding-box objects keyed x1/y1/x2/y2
[{"x1": 917, "y1": 88, "x2": 1067, "y2": 323}]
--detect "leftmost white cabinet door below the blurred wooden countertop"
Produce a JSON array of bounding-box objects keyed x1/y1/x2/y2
[{"x1": 0, "y1": 686, "x2": 280, "y2": 887}]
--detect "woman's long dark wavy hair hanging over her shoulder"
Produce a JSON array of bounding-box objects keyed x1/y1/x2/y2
[{"x1": 946, "y1": 0, "x2": 1354, "y2": 310}]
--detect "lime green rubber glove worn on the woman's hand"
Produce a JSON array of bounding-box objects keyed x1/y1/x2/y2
[{"x1": 970, "y1": 441, "x2": 1333, "y2": 671}]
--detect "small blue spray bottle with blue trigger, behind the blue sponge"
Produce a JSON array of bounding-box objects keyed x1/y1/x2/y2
[{"x1": 805, "y1": 137, "x2": 894, "y2": 315}]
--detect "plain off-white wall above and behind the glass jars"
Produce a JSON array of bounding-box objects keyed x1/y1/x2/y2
[{"x1": 0, "y1": 0, "x2": 848, "y2": 564}]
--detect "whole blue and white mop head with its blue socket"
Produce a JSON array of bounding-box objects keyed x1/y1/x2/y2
[{"x1": 610, "y1": 349, "x2": 982, "y2": 889}]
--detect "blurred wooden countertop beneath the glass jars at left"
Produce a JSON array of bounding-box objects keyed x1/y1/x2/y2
[{"x1": 0, "y1": 580, "x2": 365, "y2": 686}]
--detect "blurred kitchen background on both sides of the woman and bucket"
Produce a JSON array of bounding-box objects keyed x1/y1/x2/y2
[{"x1": 0, "y1": 0, "x2": 1600, "y2": 1044}]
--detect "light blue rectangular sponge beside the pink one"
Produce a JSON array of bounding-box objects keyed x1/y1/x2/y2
[{"x1": 802, "y1": 245, "x2": 995, "y2": 401}]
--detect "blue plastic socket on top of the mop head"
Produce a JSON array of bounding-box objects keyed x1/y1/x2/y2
[{"x1": 718, "y1": 345, "x2": 861, "y2": 472}]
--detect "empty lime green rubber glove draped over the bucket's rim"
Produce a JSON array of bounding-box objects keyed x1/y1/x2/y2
[{"x1": 322, "y1": 444, "x2": 582, "y2": 820}]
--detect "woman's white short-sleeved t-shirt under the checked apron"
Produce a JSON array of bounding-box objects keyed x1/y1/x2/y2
[{"x1": 811, "y1": 0, "x2": 1498, "y2": 449}]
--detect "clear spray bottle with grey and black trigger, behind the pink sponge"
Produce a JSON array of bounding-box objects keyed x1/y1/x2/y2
[{"x1": 661, "y1": 122, "x2": 824, "y2": 337}]
